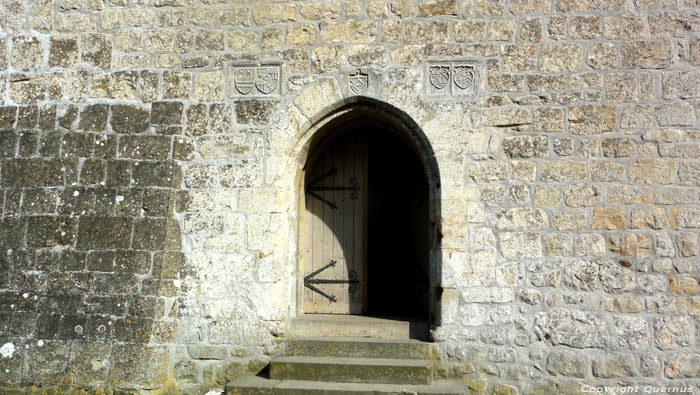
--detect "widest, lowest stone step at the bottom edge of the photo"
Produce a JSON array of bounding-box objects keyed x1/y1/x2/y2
[{"x1": 226, "y1": 376, "x2": 469, "y2": 395}]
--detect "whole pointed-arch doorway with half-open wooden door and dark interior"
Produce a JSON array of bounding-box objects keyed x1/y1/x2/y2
[{"x1": 299, "y1": 103, "x2": 439, "y2": 338}]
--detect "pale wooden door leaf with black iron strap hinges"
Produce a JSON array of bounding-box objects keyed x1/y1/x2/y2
[{"x1": 301, "y1": 133, "x2": 367, "y2": 314}]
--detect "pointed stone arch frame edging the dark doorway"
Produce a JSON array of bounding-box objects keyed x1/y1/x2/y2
[{"x1": 294, "y1": 96, "x2": 442, "y2": 328}]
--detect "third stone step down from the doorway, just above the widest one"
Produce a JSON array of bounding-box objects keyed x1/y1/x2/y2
[{"x1": 270, "y1": 357, "x2": 433, "y2": 384}]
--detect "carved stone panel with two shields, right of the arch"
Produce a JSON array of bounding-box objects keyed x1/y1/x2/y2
[{"x1": 426, "y1": 61, "x2": 478, "y2": 98}]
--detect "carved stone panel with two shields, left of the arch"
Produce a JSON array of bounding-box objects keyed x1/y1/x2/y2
[{"x1": 229, "y1": 65, "x2": 281, "y2": 96}]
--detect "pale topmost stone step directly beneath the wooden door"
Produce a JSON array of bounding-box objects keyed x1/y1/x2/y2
[{"x1": 289, "y1": 314, "x2": 427, "y2": 339}]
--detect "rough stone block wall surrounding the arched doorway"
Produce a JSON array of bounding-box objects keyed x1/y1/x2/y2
[{"x1": 0, "y1": 0, "x2": 700, "y2": 394}]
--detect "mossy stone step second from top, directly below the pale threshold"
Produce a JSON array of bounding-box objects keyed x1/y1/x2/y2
[{"x1": 286, "y1": 337, "x2": 431, "y2": 359}]
